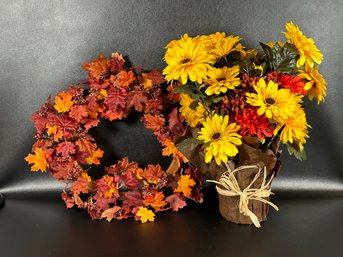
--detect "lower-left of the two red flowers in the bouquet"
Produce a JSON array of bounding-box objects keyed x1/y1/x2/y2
[{"x1": 236, "y1": 108, "x2": 273, "y2": 140}]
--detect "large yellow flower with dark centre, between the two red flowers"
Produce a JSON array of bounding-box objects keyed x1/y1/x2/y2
[{"x1": 246, "y1": 78, "x2": 301, "y2": 123}]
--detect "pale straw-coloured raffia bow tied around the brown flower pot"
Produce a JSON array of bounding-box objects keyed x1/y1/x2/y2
[{"x1": 207, "y1": 165, "x2": 279, "y2": 228}]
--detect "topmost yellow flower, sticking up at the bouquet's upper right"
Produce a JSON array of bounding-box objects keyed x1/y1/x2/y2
[{"x1": 284, "y1": 22, "x2": 323, "y2": 68}]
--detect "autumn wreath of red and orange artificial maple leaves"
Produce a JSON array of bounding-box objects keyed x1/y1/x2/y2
[{"x1": 25, "y1": 53, "x2": 204, "y2": 223}]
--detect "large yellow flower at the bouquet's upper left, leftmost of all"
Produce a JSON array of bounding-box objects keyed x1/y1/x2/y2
[{"x1": 163, "y1": 37, "x2": 214, "y2": 85}]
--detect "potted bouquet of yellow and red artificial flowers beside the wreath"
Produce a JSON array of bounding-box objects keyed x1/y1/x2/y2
[{"x1": 163, "y1": 22, "x2": 326, "y2": 226}]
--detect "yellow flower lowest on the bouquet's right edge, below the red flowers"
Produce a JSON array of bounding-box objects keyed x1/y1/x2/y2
[{"x1": 275, "y1": 107, "x2": 309, "y2": 151}]
